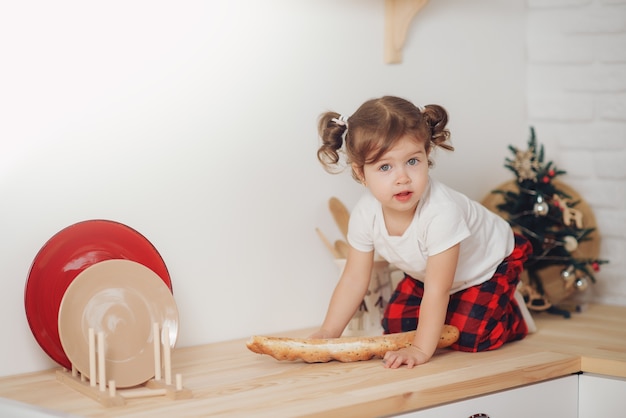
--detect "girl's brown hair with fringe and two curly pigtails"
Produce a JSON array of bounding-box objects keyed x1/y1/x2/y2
[{"x1": 317, "y1": 96, "x2": 454, "y2": 181}]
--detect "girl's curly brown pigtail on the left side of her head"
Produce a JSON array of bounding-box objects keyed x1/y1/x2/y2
[{"x1": 317, "y1": 112, "x2": 348, "y2": 173}]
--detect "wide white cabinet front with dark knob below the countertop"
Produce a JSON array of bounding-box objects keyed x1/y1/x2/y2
[{"x1": 399, "y1": 375, "x2": 576, "y2": 418}]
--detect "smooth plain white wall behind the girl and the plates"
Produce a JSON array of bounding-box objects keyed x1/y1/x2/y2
[{"x1": 0, "y1": 0, "x2": 528, "y2": 375}]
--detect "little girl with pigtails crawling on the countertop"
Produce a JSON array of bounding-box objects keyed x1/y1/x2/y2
[{"x1": 311, "y1": 96, "x2": 531, "y2": 368}]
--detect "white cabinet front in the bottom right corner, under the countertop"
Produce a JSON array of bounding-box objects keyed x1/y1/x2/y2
[{"x1": 578, "y1": 373, "x2": 626, "y2": 418}]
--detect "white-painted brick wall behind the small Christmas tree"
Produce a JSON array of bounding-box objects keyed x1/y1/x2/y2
[{"x1": 528, "y1": 0, "x2": 626, "y2": 305}]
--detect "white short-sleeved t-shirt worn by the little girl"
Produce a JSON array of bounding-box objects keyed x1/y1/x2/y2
[{"x1": 348, "y1": 178, "x2": 515, "y2": 293}]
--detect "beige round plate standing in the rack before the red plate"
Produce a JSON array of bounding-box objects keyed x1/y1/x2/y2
[{"x1": 58, "y1": 260, "x2": 178, "y2": 388}]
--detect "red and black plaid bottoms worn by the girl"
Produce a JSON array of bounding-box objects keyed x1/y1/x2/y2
[{"x1": 382, "y1": 234, "x2": 532, "y2": 352}]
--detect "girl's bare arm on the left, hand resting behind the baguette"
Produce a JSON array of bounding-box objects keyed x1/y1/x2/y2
[{"x1": 310, "y1": 246, "x2": 372, "y2": 338}]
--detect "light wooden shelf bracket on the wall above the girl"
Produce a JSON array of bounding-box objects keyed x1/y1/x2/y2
[{"x1": 385, "y1": 0, "x2": 428, "y2": 64}]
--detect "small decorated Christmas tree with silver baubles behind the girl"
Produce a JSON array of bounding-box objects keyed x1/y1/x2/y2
[{"x1": 492, "y1": 127, "x2": 607, "y2": 316}]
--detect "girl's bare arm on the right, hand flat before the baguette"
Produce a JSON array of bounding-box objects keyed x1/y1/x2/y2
[{"x1": 383, "y1": 244, "x2": 460, "y2": 369}]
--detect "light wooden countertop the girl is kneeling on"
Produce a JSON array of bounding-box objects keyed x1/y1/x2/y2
[{"x1": 0, "y1": 305, "x2": 626, "y2": 418}]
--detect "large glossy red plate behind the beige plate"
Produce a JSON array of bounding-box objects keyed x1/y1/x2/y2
[{"x1": 24, "y1": 219, "x2": 172, "y2": 369}]
